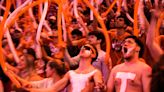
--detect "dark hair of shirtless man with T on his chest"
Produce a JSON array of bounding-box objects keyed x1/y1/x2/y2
[{"x1": 124, "y1": 35, "x2": 144, "y2": 57}]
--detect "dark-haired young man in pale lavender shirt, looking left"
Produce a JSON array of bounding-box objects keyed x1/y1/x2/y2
[{"x1": 88, "y1": 30, "x2": 112, "y2": 83}]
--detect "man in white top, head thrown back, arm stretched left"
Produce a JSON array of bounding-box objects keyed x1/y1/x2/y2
[{"x1": 30, "y1": 44, "x2": 104, "y2": 92}]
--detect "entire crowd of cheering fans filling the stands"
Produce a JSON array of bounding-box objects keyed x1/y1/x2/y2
[{"x1": 0, "y1": 0, "x2": 164, "y2": 92}]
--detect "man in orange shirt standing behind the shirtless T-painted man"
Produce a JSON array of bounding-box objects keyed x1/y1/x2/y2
[{"x1": 108, "y1": 14, "x2": 131, "y2": 66}]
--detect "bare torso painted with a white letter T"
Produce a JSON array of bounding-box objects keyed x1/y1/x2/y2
[{"x1": 113, "y1": 62, "x2": 149, "y2": 92}]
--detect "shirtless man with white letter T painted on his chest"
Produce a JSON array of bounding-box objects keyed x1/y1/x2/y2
[{"x1": 107, "y1": 36, "x2": 151, "y2": 92}]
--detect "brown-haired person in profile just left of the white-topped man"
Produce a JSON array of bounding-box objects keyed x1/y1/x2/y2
[{"x1": 16, "y1": 59, "x2": 67, "y2": 92}]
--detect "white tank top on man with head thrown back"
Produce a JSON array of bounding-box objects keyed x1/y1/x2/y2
[{"x1": 69, "y1": 69, "x2": 97, "y2": 92}]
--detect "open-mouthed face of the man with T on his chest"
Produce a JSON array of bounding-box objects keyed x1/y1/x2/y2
[{"x1": 122, "y1": 38, "x2": 138, "y2": 59}]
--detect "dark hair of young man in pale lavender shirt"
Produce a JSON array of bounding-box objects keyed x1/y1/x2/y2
[{"x1": 88, "y1": 30, "x2": 105, "y2": 44}]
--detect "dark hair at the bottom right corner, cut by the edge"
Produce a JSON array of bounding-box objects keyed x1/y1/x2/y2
[{"x1": 150, "y1": 54, "x2": 164, "y2": 92}]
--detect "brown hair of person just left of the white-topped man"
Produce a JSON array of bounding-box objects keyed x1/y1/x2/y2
[{"x1": 48, "y1": 60, "x2": 66, "y2": 76}]
